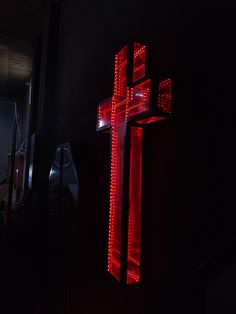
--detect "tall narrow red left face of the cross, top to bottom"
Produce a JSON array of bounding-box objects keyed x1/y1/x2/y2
[{"x1": 108, "y1": 47, "x2": 128, "y2": 280}]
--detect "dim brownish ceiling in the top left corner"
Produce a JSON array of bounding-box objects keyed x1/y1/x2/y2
[{"x1": 0, "y1": 0, "x2": 48, "y2": 98}]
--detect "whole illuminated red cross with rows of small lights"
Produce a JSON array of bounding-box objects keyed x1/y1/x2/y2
[{"x1": 97, "y1": 43, "x2": 172, "y2": 284}]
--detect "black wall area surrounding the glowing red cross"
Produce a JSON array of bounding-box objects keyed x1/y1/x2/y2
[{"x1": 1, "y1": 0, "x2": 236, "y2": 314}]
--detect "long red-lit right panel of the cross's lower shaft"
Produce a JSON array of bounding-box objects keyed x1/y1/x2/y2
[{"x1": 127, "y1": 127, "x2": 143, "y2": 284}]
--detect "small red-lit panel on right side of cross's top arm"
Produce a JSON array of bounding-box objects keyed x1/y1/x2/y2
[{"x1": 133, "y1": 43, "x2": 146, "y2": 82}]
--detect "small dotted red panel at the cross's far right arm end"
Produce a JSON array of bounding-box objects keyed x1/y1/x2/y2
[{"x1": 158, "y1": 79, "x2": 172, "y2": 113}]
